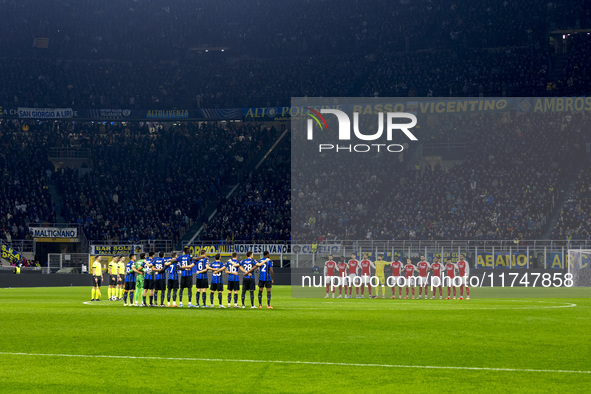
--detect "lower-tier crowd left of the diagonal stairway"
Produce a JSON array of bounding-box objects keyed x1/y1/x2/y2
[{"x1": 0, "y1": 121, "x2": 277, "y2": 242}]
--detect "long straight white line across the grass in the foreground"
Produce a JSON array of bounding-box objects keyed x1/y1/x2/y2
[{"x1": 0, "y1": 352, "x2": 591, "y2": 374}]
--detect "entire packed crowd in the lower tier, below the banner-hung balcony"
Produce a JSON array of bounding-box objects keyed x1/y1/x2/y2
[{"x1": 0, "y1": 113, "x2": 591, "y2": 246}]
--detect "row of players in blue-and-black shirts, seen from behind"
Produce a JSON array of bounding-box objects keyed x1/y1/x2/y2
[{"x1": 102, "y1": 248, "x2": 273, "y2": 309}]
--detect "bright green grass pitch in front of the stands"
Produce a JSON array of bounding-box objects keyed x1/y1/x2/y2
[{"x1": 0, "y1": 286, "x2": 591, "y2": 393}]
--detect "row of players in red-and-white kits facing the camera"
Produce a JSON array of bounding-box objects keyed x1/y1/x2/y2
[{"x1": 324, "y1": 253, "x2": 470, "y2": 300}]
